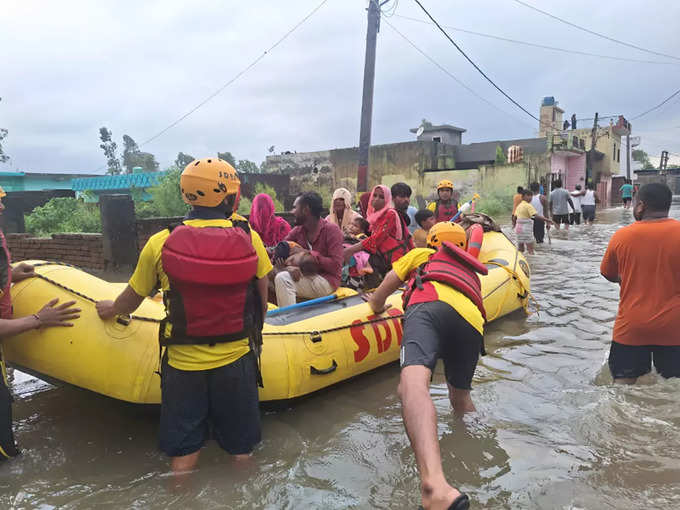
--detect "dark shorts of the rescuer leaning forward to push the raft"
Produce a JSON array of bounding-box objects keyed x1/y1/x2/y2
[{"x1": 400, "y1": 301, "x2": 484, "y2": 390}]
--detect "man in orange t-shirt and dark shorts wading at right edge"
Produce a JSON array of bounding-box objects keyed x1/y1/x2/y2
[{"x1": 600, "y1": 183, "x2": 680, "y2": 384}]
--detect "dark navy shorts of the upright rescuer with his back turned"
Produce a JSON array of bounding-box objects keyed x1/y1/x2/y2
[{"x1": 159, "y1": 353, "x2": 261, "y2": 457}]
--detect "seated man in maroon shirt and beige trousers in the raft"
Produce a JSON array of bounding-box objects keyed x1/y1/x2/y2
[{"x1": 274, "y1": 191, "x2": 342, "y2": 307}]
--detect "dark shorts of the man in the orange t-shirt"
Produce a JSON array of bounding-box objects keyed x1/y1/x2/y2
[{"x1": 609, "y1": 342, "x2": 680, "y2": 379}]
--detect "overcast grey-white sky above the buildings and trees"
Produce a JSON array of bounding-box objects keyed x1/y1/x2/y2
[{"x1": 0, "y1": 0, "x2": 680, "y2": 173}]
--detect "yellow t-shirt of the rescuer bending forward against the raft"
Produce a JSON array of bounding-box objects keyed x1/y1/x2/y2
[{"x1": 392, "y1": 248, "x2": 484, "y2": 335}]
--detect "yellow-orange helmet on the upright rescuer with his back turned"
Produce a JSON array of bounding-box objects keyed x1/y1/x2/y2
[{"x1": 179, "y1": 158, "x2": 241, "y2": 207}]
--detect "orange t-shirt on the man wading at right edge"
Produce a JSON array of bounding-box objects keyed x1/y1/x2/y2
[{"x1": 600, "y1": 218, "x2": 680, "y2": 345}]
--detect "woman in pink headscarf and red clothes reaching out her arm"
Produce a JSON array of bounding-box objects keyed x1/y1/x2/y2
[{"x1": 344, "y1": 185, "x2": 413, "y2": 284}]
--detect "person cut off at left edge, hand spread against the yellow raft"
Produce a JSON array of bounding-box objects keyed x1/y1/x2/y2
[{"x1": 0, "y1": 188, "x2": 80, "y2": 460}]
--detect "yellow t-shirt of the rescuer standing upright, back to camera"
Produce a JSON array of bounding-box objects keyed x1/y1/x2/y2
[{"x1": 128, "y1": 216, "x2": 272, "y2": 370}]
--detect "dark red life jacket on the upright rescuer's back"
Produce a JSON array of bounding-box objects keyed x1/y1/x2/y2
[{"x1": 159, "y1": 221, "x2": 261, "y2": 345}]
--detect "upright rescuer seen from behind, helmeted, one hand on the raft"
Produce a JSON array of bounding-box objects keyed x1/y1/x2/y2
[{"x1": 97, "y1": 158, "x2": 272, "y2": 473}]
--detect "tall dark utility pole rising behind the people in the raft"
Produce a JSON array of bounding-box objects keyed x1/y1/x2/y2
[{"x1": 357, "y1": 0, "x2": 389, "y2": 191}]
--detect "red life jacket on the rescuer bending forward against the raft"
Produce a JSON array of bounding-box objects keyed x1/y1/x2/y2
[{"x1": 403, "y1": 241, "x2": 489, "y2": 320}]
